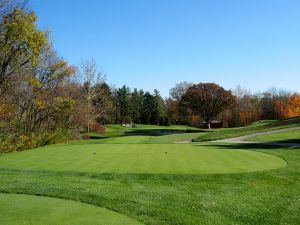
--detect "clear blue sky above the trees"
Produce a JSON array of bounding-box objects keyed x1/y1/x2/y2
[{"x1": 30, "y1": 0, "x2": 300, "y2": 97}]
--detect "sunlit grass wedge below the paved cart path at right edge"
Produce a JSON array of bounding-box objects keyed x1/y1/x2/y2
[{"x1": 247, "y1": 129, "x2": 300, "y2": 143}]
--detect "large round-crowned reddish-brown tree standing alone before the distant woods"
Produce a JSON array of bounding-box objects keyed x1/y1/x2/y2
[{"x1": 181, "y1": 83, "x2": 234, "y2": 128}]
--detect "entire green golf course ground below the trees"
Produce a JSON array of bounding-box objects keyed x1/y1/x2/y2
[{"x1": 0, "y1": 119, "x2": 300, "y2": 225}]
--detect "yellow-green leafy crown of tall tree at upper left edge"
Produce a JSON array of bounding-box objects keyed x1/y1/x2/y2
[{"x1": 0, "y1": 8, "x2": 47, "y2": 96}]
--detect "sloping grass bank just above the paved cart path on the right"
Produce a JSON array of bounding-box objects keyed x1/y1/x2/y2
[{"x1": 194, "y1": 117, "x2": 300, "y2": 142}]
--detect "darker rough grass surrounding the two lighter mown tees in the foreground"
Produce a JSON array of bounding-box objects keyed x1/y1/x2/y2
[{"x1": 0, "y1": 144, "x2": 300, "y2": 225}]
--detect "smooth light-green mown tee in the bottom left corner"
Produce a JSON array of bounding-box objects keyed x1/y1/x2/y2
[{"x1": 0, "y1": 194, "x2": 141, "y2": 225}]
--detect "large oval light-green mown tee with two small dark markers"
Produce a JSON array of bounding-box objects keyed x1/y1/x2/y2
[{"x1": 0, "y1": 144, "x2": 286, "y2": 174}]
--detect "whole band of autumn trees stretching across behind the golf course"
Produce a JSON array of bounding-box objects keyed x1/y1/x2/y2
[{"x1": 0, "y1": 0, "x2": 300, "y2": 152}]
